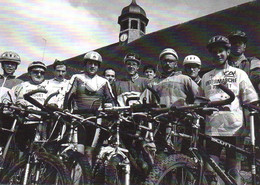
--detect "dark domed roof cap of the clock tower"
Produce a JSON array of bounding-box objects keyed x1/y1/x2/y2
[{"x1": 118, "y1": 0, "x2": 149, "y2": 24}]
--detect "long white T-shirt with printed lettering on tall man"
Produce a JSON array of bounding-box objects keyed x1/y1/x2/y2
[{"x1": 201, "y1": 65, "x2": 258, "y2": 136}]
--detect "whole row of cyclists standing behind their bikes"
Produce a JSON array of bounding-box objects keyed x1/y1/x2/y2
[{"x1": 0, "y1": 30, "x2": 260, "y2": 183}]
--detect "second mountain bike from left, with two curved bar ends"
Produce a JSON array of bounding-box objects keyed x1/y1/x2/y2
[{"x1": 22, "y1": 90, "x2": 96, "y2": 184}]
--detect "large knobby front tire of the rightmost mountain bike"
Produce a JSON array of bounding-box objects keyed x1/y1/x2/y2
[{"x1": 144, "y1": 154, "x2": 207, "y2": 185}]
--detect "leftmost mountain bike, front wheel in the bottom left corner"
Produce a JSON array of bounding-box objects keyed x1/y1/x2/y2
[{"x1": 0, "y1": 100, "x2": 70, "y2": 184}]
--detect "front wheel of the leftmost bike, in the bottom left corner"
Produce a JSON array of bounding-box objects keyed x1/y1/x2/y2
[{"x1": 2, "y1": 152, "x2": 71, "y2": 185}]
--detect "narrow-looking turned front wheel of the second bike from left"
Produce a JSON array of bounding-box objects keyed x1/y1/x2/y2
[{"x1": 66, "y1": 150, "x2": 92, "y2": 184}]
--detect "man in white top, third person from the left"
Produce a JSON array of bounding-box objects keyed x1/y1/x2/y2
[{"x1": 47, "y1": 59, "x2": 69, "y2": 108}]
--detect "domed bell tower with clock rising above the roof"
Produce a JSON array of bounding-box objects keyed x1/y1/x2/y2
[{"x1": 118, "y1": 0, "x2": 149, "y2": 45}]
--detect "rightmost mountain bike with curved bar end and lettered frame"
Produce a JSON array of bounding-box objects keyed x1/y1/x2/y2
[{"x1": 145, "y1": 86, "x2": 260, "y2": 184}]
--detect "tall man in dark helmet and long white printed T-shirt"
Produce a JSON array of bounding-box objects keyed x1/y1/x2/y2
[{"x1": 201, "y1": 35, "x2": 258, "y2": 184}]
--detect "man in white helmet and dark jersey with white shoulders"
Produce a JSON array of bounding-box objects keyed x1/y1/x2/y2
[{"x1": 64, "y1": 51, "x2": 114, "y2": 152}]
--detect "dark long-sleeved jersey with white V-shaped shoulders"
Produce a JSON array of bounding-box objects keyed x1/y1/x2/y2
[{"x1": 64, "y1": 74, "x2": 114, "y2": 110}]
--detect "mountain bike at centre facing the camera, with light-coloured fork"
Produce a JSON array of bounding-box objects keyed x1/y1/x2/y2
[{"x1": 93, "y1": 102, "x2": 155, "y2": 185}]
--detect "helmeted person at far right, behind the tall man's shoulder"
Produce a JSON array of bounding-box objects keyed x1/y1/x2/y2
[{"x1": 228, "y1": 30, "x2": 260, "y2": 93}]
